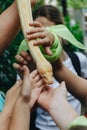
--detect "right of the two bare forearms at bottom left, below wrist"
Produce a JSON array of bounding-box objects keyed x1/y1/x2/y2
[{"x1": 9, "y1": 97, "x2": 30, "y2": 130}]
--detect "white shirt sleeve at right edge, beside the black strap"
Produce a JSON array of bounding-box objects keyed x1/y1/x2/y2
[{"x1": 75, "y1": 52, "x2": 87, "y2": 78}]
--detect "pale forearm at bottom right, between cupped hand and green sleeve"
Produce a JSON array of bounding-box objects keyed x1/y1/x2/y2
[{"x1": 49, "y1": 100, "x2": 79, "y2": 130}]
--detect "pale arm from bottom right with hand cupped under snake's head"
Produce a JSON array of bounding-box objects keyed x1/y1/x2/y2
[{"x1": 38, "y1": 83, "x2": 79, "y2": 130}]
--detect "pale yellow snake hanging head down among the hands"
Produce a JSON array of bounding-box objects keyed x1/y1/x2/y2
[{"x1": 16, "y1": 0, "x2": 53, "y2": 84}]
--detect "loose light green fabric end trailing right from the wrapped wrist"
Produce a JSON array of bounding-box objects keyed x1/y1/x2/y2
[{"x1": 48, "y1": 24, "x2": 87, "y2": 50}]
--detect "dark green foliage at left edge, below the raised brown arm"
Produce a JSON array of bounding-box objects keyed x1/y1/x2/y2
[{"x1": 0, "y1": 32, "x2": 23, "y2": 92}]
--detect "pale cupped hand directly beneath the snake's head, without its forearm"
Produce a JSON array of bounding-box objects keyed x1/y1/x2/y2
[{"x1": 38, "y1": 82, "x2": 67, "y2": 112}]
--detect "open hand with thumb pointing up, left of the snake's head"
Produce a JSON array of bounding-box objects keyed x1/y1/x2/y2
[{"x1": 21, "y1": 66, "x2": 45, "y2": 108}]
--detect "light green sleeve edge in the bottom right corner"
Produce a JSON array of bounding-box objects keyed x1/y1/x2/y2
[{"x1": 68, "y1": 116, "x2": 87, "y2": 129}]
